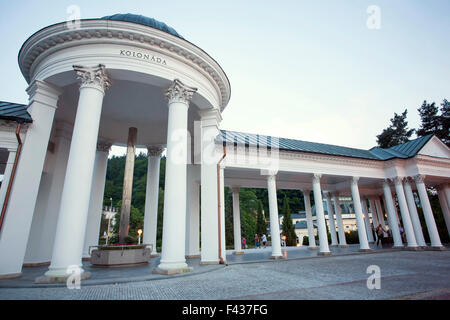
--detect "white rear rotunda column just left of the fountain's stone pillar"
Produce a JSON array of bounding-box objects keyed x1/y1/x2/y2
[{"x1": 83, "y1": 142, "x2": 112, "y2": 258}]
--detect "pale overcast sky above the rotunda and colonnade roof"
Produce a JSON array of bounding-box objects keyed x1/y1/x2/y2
[{"x1": 0, "y1": 0, "x2": 450, "y2": 154}]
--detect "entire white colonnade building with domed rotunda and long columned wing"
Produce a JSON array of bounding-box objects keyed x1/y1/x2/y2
[{"x1": 0, "y1": 14, "x2": 450, "y2": 278}]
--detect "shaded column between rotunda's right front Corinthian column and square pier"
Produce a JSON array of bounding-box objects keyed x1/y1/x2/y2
[{"x1": 186, "y1": 165, "x2": 200, "y2": 258}]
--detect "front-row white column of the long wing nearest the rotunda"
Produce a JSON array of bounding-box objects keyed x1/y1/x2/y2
[{"x1": 267, "y1": 175, "x2": 283, "y2": 259}]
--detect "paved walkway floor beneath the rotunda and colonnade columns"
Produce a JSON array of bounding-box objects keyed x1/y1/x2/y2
[{"x1": 0, "y1": 244, "x2": 440, "y2": 289}]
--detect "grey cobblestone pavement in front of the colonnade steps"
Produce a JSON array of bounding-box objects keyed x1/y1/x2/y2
[{"x1": 0, "y1": 250, "x2": 450, "y2": 300}]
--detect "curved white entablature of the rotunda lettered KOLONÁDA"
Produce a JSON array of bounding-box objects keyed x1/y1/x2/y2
[{"x1": 18, "y1": 19, "x2": 231, "y2": 111}]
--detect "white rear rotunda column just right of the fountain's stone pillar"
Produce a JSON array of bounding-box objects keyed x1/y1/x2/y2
[{"x1": 142, "y1": 146, "x2": 164, "y2": 257}]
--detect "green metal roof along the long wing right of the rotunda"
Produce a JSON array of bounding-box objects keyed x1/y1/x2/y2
[{"x1": 221, "y1": 130, "x2": 432, "y2": 160}]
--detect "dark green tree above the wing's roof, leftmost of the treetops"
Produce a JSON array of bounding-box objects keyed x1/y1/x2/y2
[{"x1": 377, "y1": 109, "x2": 415, "y2": 148}]
